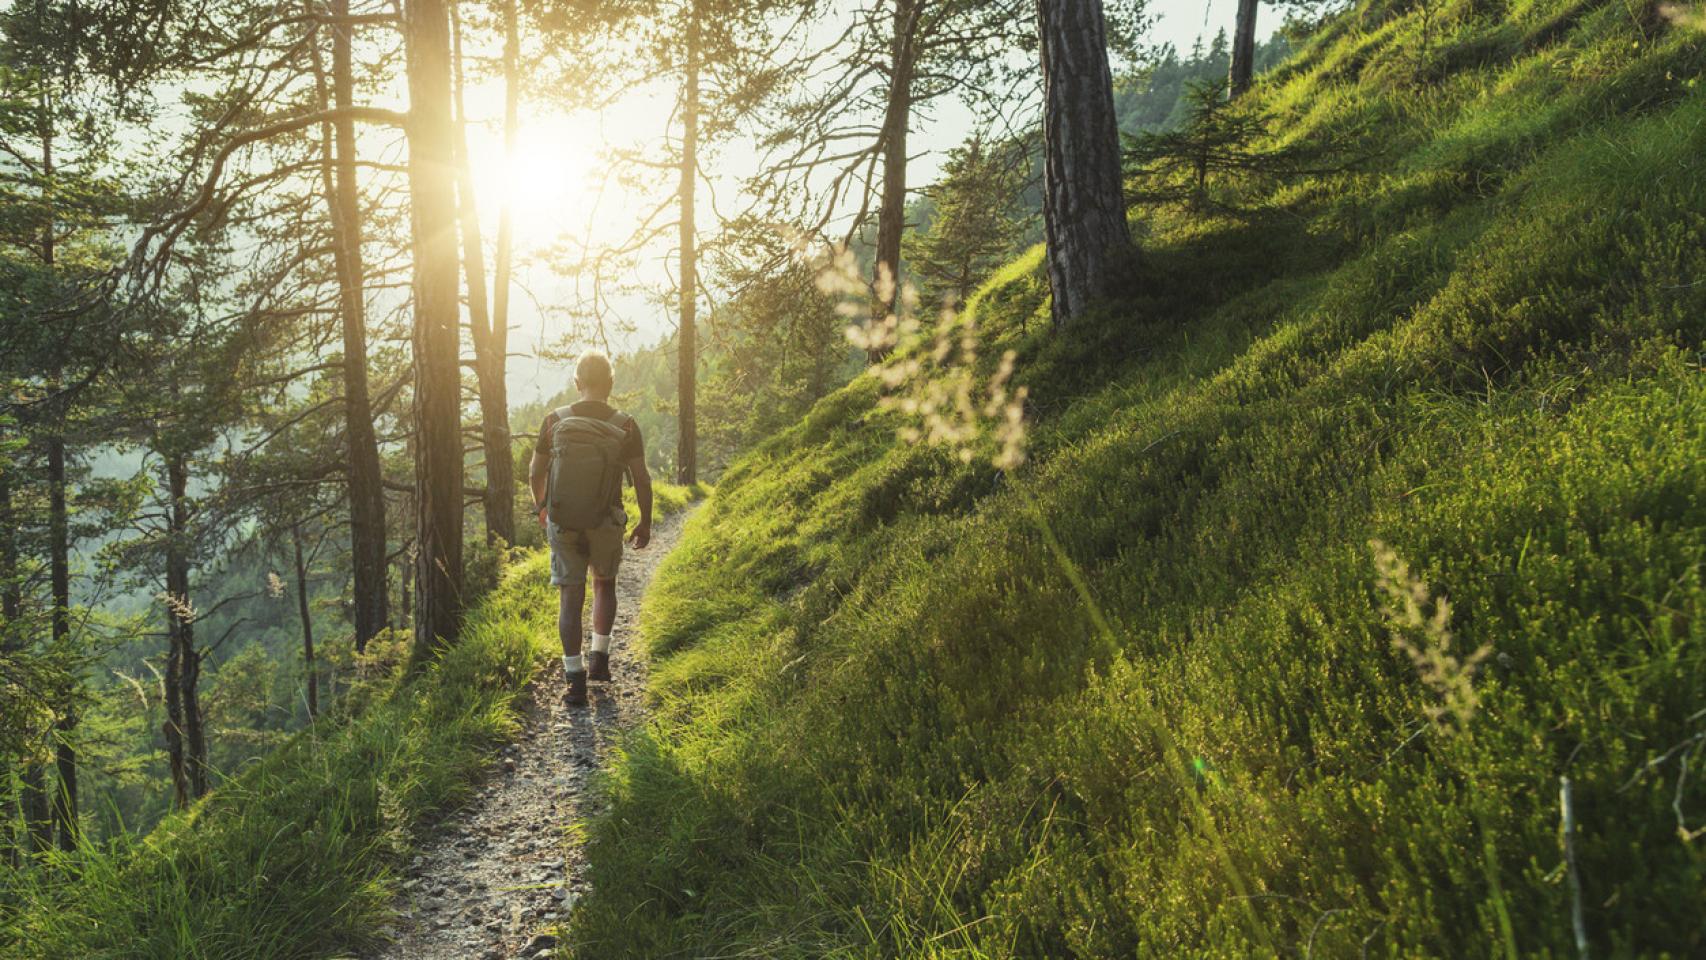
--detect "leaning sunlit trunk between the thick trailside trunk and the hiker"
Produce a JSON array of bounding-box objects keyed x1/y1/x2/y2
[{"x1": 450, "y1": 0, "x2": 515, "y2": 544}]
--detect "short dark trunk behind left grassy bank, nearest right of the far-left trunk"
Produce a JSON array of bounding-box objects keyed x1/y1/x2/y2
[{"x1": 165, "y1": 454, "x2": 208, "y2": 808}]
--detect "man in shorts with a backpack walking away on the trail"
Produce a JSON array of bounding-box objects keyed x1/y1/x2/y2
[{"x1": 527, "y1": 351, "x2": 652, "y2": 706}]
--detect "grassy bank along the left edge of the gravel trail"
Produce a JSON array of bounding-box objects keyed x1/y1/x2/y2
[{"x1": 0, "y1": 484, "x2": 701, "y2": 960}]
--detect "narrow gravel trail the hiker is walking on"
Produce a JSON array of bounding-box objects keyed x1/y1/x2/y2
[{"x1": 368, "y1": 513, "x2": 686, "y2": 960}]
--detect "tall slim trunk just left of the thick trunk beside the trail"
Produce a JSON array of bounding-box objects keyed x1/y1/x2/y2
[{"x1": 329, "y1": 0, "x2": 387, "y2": 653}]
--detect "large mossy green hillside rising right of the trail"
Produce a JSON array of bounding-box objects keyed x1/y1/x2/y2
[{"x1": 572, "y1": 0, "x2": 1706, "y2": 957}]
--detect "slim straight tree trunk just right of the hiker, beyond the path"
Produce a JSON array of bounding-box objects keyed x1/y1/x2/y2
[{"x1": 676, "y1": 3, "x2": 699, "y2": 484}]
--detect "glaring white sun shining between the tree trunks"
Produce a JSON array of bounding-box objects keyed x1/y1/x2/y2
[{"x1": 467, "y1": 116, "x2": 601, "y2": 247}]
